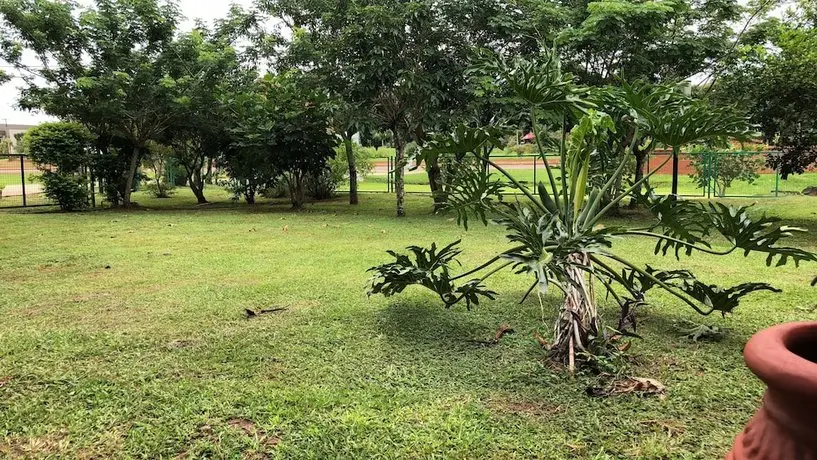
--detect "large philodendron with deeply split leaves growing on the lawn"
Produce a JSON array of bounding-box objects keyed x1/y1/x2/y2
[{"x1": 369, "y1": 55, "x2": 817, "y2": 372}]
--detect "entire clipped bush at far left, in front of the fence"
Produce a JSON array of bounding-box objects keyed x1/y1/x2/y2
[{"x1": 23, "y1": 122, "x2": 93, "y2": 211}]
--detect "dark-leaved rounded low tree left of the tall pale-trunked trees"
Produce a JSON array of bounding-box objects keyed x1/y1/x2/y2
[{"x1": 224, "y1": 72, "x2": 337, "y2": 209}]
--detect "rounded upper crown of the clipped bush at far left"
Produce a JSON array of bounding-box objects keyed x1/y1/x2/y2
[{"x1": 23, "y1": 122, "x2": 93, "y2": 173}]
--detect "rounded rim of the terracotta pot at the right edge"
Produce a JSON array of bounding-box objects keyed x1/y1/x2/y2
[{"x1": 744, "y1": 321, "x2": 817, "y2": 395}]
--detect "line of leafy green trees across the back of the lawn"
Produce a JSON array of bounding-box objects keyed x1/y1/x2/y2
[{"x1": 0, "y1": 0, "x2": 817, "y2": 215}]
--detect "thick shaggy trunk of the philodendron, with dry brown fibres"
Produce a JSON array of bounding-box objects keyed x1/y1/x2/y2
[{"x1": 551, "y1": 253, "x2": 601, "y2": 373}]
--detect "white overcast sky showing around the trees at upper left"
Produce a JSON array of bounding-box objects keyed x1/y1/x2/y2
[{"x1": 0, "y1": 0, "x2": 252, "y2": 125}]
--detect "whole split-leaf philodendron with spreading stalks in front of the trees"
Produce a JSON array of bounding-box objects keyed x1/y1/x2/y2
[{"x1": 371, "y1": 52, "x2": 817, "y2": 366}]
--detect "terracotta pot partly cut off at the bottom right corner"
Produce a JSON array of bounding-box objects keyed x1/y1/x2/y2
[{"x1": 726, "y1": 322, "x2": 817, "y2": 460}]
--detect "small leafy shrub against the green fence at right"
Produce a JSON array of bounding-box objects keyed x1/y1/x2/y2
[{"x1": 689, "y1": 153, "x2": 765, "y2": 197}]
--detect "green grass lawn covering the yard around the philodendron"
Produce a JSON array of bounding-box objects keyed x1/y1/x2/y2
[{"x1": 0, "y1": 190, "x2": 817, "y2": 459}]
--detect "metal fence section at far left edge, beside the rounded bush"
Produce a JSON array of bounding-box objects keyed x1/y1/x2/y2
[{"x1": 0, "y1": 154, "x2": 53, "y2": 208}]
